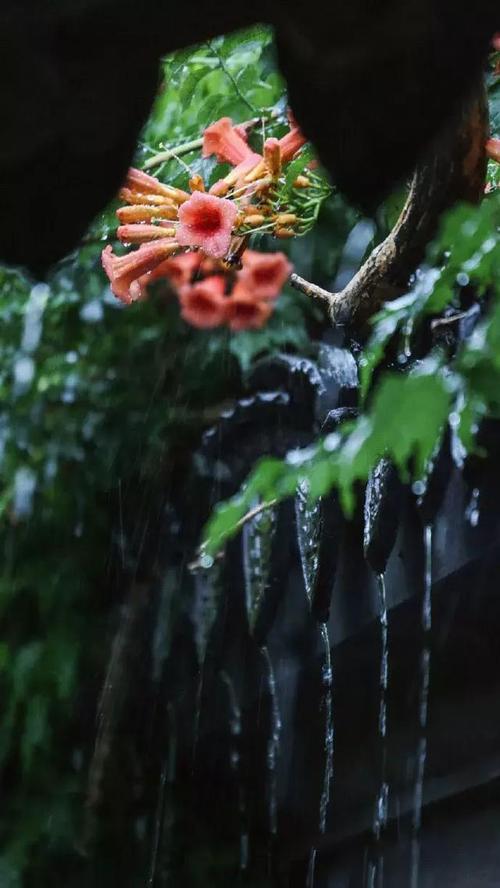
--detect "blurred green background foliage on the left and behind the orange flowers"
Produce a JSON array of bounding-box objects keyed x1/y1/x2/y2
[{"x1": 0, "y1": 22, "x2": 324, "y2": 888}]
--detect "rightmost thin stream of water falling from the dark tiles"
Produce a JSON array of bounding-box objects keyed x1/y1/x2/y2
[{"x1": 410, "y1": 524, "x2": 432, "y2": 888}]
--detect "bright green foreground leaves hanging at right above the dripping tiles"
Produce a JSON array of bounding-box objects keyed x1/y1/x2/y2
[{"x1": 202, "y1": 193, "x2": 500, "y2": 556}]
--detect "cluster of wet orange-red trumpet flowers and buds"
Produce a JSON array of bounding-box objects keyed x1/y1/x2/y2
[{"x1": 102, "y1": 117, "x2": 328, "y2": 330}]
